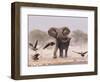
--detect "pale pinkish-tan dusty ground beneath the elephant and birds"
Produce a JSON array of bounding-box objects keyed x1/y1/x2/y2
[{"x1": 28, "y1": 45, "x2": 88, "y2": 66}]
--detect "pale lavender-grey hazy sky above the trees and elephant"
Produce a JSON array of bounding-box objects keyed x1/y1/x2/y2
[{"x1": 28, "y1": 15, "x2": 88, "y2": 33}]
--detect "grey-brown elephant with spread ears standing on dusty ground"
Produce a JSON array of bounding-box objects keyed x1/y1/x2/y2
[{"x1": 48, "y1": 27, "x2": 71, "y2": 58}]
